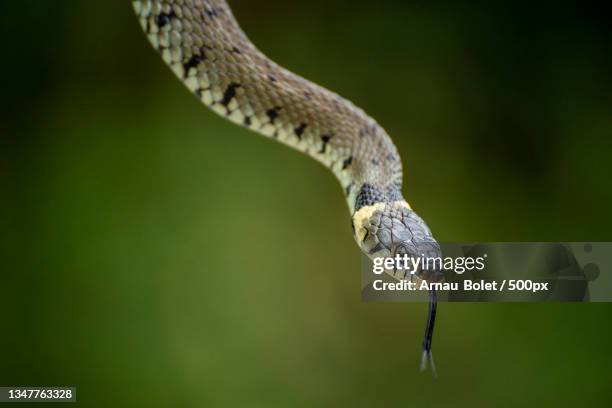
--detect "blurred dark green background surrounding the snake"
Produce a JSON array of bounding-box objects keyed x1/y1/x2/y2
[{"x1": 0, "y1": 0, "x2": 612, "y2": 407}]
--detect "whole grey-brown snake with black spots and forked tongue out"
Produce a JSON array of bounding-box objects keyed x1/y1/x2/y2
[{"x1": 132, "y1": 0, "x2": 440, "y2": 372}]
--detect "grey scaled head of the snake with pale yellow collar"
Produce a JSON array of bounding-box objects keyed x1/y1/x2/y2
[{"x1": 353, "y1": 200, "x2": 443, "y2": 282}]
